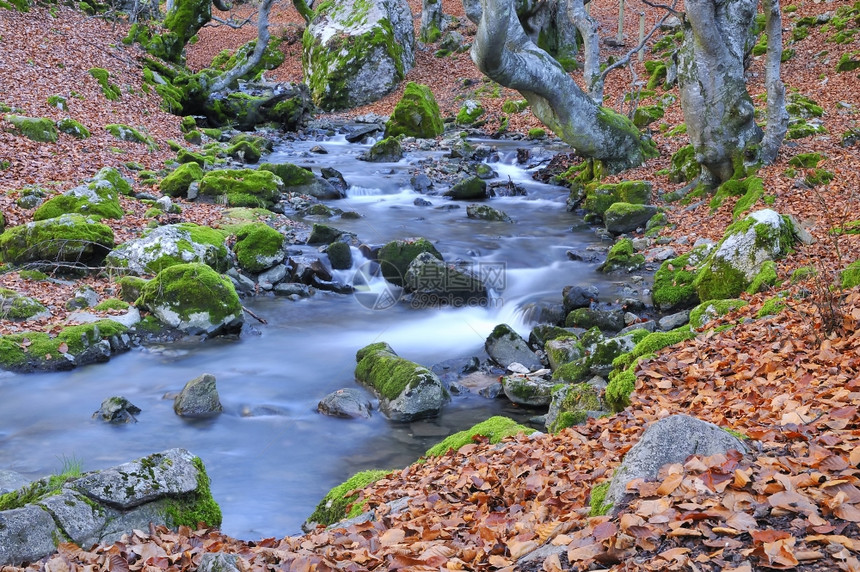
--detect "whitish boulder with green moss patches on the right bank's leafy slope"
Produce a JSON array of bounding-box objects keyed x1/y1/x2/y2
[{"x1": 693, "y1": 209, "x2": 795, "y2": 302}]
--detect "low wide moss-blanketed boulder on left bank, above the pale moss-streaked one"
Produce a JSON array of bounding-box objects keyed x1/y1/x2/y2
[{"x1": 200, "y1": 169, "x2": 284, "y2": 208}]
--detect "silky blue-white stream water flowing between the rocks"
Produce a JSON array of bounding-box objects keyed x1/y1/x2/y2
[{"x1": 0, "y1": 133, "x2": 620, "y2": 539}]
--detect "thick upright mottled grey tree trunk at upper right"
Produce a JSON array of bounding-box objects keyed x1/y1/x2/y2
[{"x1": 678, "y1": 0, "x2": 762, "y2": 183}]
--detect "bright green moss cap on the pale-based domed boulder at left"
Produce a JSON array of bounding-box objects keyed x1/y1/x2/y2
[{"x1": 136, "y1": 263, "x2": 242, "y2": 324}]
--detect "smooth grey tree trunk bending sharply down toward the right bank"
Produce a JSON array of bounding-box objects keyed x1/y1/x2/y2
[{"x1": 471, "y1": 0, "x2": 656, "y2": 172}]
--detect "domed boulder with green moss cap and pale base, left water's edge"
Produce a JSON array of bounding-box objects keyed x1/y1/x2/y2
[{"x1": 137, "y1": 263, "x2": 245, "y2": 336}]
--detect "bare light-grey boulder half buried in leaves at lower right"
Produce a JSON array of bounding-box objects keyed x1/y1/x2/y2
[{"x1": 603, "y1": 415, "x2": 747, "y2": 509}]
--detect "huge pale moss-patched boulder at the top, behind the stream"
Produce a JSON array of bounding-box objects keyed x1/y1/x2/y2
[{"x1": 302, "y1": 0, "x2": 415, "y2": 110}]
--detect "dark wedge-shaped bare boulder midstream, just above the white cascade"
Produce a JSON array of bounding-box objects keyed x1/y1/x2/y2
[{"x1": 403, "y1": 252, "x2": 488, "y2": 307}]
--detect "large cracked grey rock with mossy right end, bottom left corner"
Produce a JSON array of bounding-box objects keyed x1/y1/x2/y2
[{"x1": 0, "y1": 449, "x2": 221, "y2": 566}]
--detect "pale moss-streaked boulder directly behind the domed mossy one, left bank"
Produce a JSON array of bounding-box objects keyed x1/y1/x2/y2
[{"x1": 105, "y1": 223, "x2": 230, "y2": 275}]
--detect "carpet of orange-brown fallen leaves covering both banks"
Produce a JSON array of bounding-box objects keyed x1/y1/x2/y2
[{"x1": 0, "y1": 0, "x2": 860, "y2": 571}]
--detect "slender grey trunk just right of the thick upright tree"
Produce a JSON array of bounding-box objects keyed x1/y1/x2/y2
[{"x1": 761, "y1": 0, "x2": 788, "y2": 164}]
